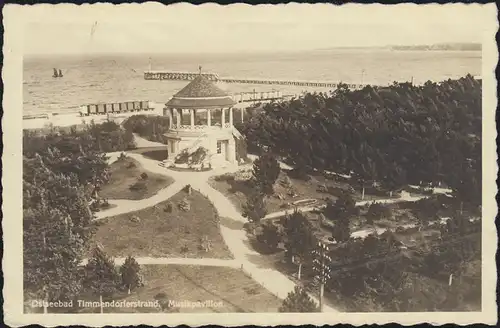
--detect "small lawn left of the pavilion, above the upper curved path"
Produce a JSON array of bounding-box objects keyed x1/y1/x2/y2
[{"x1": 99, "y1": 157, "x2": 174, "y2": 200}]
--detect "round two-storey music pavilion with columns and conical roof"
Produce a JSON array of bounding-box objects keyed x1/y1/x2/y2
[{"x1": 164, "y1": 75, "x2": 246, "y2": 170}]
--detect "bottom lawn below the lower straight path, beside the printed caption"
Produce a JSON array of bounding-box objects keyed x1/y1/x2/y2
[{"x1": 76, "y1": 265, "x2": 281, "y2": 313}]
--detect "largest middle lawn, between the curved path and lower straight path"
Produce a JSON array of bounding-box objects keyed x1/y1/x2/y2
[{"x1": 95, "y1": 190, "x2": 232, "y2": 259}]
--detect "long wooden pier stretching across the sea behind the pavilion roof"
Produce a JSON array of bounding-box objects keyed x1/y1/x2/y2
[{"x1": 144, "y1": 71, "x2": 365, "y2": 89}]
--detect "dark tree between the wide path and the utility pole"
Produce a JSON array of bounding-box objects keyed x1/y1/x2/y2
[{"x1": 284, "y1": 210, "x2": 317, "y2": 279}]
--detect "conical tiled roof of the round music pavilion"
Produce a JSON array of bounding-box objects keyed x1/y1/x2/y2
[{"x1": 166, "y1": 75, "x2": 235, "y2": 109}]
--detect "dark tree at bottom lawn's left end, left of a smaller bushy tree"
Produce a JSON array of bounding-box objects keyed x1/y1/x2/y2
[{"x1": 84, "y1": 247, "x2": 120, "y2": 313}]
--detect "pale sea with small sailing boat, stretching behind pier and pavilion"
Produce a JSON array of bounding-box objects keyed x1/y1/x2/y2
[{"x1": 23, "y1": 49, "x2": 481, "y2": 115}]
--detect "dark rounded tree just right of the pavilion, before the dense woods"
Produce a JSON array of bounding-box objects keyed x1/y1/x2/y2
[{"x1": 253, "y1": 152, "x2": 281, "y2": 195}]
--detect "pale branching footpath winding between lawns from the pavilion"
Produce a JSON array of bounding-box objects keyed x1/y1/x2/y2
[{"x1": 96, "y1": 153, "x2": 337, "y2": 312}]
